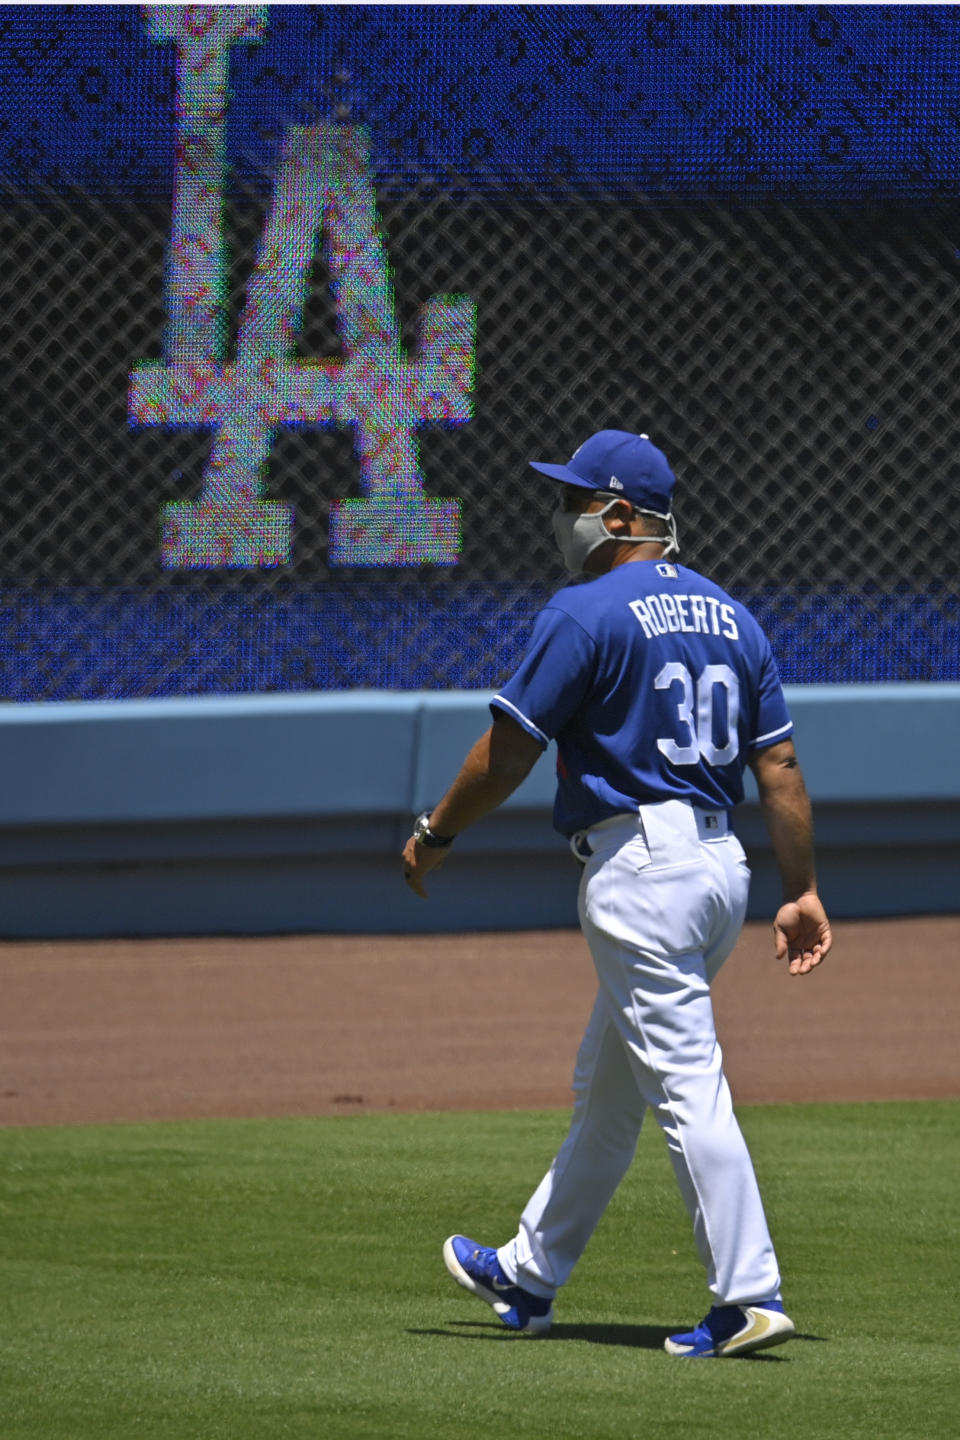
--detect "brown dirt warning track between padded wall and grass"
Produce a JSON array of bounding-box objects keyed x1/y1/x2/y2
[{"x1": 0, "y1": 916, "x2": 960, "y2": 1125}]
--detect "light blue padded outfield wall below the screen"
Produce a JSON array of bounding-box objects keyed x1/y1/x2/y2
[{"x1": 0, "y1": 684, "x2": 960, "y2": 944}]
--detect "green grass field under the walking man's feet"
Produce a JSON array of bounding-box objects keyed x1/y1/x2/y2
[{"x1": 0, "y1": 1102, "x2": 960, "y2": 1440}]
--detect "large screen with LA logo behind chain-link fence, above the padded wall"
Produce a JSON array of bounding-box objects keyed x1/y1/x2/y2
[{"x1": 0, "y1": 4, "x2": 960, "y2": 701}]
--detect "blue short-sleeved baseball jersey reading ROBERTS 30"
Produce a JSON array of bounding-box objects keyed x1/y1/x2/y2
[{"x1": 491, "y1": 560, "x2": 793, "y2": 835}]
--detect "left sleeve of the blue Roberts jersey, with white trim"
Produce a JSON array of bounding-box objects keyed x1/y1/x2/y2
[{"x1": 491, "y1": 606, "x2": 596, "y2": 749}]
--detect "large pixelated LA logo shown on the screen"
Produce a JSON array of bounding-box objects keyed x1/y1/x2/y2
[{"x1": 128, "y1": 6, "x2": 476, "y2": 569}]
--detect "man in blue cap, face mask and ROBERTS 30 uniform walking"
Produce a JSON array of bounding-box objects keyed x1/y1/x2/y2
[{"x1": 403, "y1": 431, "x2": 830, "y2": 1358}]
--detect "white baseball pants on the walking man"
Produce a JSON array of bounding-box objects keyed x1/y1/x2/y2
[{"x1": 498, "y1": 801, "x2": 780, "y2": 1305}]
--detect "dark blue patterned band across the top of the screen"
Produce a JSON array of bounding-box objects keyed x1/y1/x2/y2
[{"x1": 0, "y1": 4, "x2": 960, "y2": 202}]
